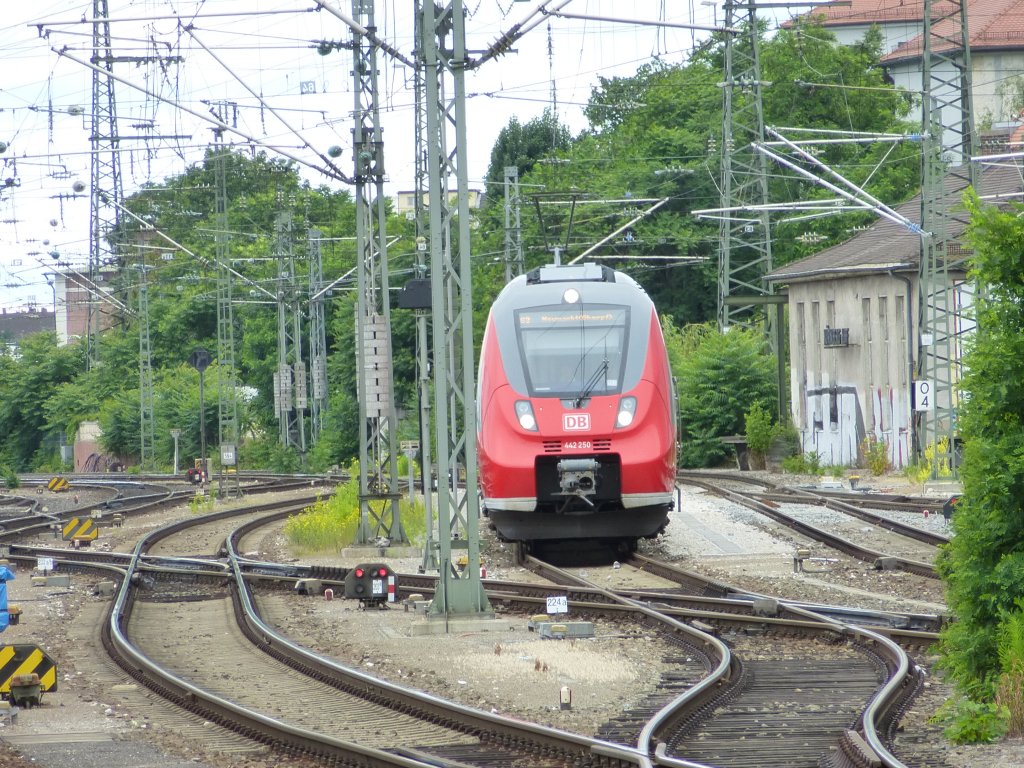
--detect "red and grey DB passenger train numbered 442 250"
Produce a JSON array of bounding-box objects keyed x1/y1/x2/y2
[{"x1": 476, "y1": 264, "x2": 676, "y2": 551}]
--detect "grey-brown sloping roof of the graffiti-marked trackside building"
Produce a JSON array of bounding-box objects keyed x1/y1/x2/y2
[{"x1": 765, "y1": 166, "x2": 1024, "y2": 283}]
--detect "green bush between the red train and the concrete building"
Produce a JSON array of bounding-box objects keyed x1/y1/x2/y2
[{"x1": 663, "y1": 318, "x2": 775, "y2": 467}]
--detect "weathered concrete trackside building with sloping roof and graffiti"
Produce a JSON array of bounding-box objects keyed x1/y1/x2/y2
[{"x1": 766, "y1": 144, "x2": 1024, "y2": 468}]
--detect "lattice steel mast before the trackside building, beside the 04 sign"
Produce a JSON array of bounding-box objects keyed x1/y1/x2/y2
[{"x1": 915, "y1": 0, "x2": 980, "y2": 476}]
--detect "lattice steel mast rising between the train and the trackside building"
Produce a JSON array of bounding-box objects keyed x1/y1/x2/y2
[{"x1": 718, "y1": 0, "x2": 774, "y2": 339}]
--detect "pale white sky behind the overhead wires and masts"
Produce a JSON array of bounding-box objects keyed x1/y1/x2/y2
[{"x1": 0, "y1": 0, "x2": 722, "y2": 311}]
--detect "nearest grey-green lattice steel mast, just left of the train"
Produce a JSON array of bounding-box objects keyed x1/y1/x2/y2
[{"x1": 420, "y1": 0, "x2": 490, "y2": 615}]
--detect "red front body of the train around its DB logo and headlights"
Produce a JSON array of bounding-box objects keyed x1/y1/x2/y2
[{"x1": 478, "y1": 274, "x2": 675, "y2": 541}]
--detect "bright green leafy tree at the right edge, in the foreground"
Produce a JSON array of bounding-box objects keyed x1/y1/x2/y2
[{"x1": 938, "y1": 196, "x2": 1024, "y2": 700}]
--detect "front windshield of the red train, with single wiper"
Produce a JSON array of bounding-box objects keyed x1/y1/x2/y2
[{"x1": 516, "y1": 304, "x2": 630, "y2": 400}]
